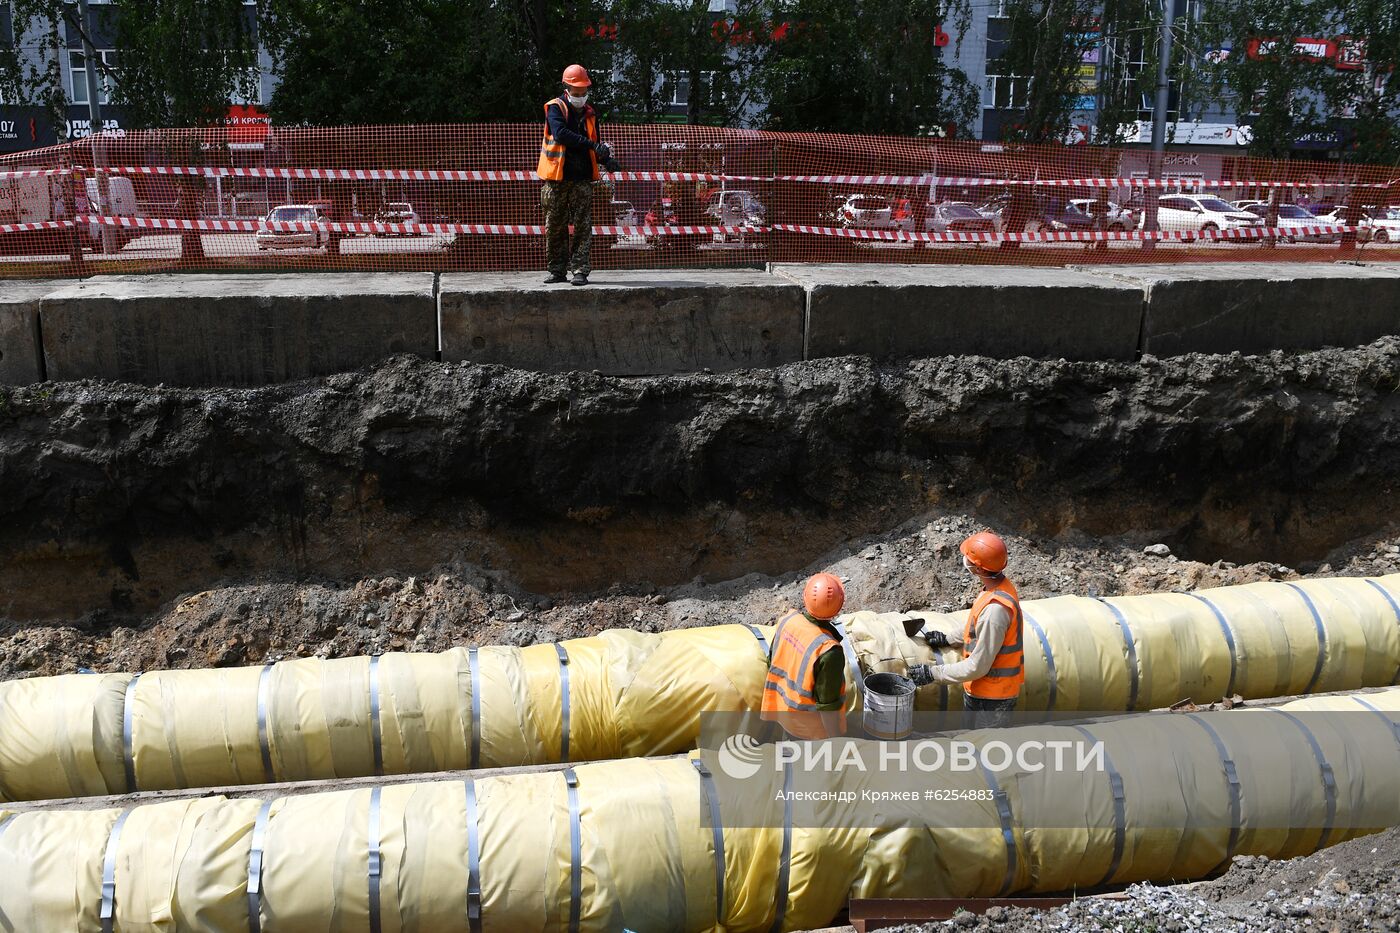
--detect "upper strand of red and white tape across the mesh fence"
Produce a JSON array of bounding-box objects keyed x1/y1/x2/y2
[{"x1": 19, "y1": 165, "x2": 1400, "y2": 191}]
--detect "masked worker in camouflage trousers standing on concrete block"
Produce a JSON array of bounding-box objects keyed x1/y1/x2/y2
[{"x1": 535, "y1": 64, "x2": 612, "y2": 286}]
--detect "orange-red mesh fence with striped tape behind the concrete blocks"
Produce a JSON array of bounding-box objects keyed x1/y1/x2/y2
[{"x1": 0, "y1": 125, "x2": 1400, "y2": 277}]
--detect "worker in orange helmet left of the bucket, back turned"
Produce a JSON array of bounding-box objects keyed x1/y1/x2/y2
[{"x1": 759, "y1": 573, "x2": 846, "y2": 738}]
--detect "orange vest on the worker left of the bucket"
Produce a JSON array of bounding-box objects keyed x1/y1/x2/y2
[{"x1": 759, "y1": 611, "x2": 846, "y2": 738}]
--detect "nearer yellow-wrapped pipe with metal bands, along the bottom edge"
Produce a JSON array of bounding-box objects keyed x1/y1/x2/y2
[{"x1": 0, "y1": 689, "x2": 1400, "y2": 933}]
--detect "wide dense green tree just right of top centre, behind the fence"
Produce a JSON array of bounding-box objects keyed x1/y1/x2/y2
[{"x1": 755, "y1": 0, "x2": 977, "y2": 134}]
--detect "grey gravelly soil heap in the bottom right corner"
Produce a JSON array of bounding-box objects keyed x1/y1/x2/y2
[{"x1": 890, "y1": 828, "x2": 1400, "y2": 933}]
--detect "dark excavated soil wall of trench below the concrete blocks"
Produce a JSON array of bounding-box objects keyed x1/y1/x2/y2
[{"x1": 0, "y1": 338, "x2": 1400, "y2": 621}]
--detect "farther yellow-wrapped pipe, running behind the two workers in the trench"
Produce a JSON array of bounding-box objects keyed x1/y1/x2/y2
[{"x1": 0, "y1": 574, "x2": 1400, "y2": 800}]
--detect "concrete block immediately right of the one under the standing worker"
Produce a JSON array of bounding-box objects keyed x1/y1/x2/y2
[{"x1": 774, "y1": 265, "x2": 1142, "y2": 360}]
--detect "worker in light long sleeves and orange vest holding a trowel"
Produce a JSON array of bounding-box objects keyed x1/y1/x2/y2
[{"x1": 909, "y1": 531, "x2": 1026, "y2": 728}]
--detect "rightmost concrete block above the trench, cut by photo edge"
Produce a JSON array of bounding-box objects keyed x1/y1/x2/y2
[{"x1": 1095, "y1": 262, "x2": 1400, "y2": 356}]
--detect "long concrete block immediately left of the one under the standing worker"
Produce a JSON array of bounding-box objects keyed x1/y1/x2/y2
[{"x1": 39, "y1": 273, "x2": 437, "y2": 387}]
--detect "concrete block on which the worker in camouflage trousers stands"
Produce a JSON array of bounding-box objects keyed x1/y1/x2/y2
[{"x1": 440, "y1": 269, "x2": 802, "y2": 375}]
